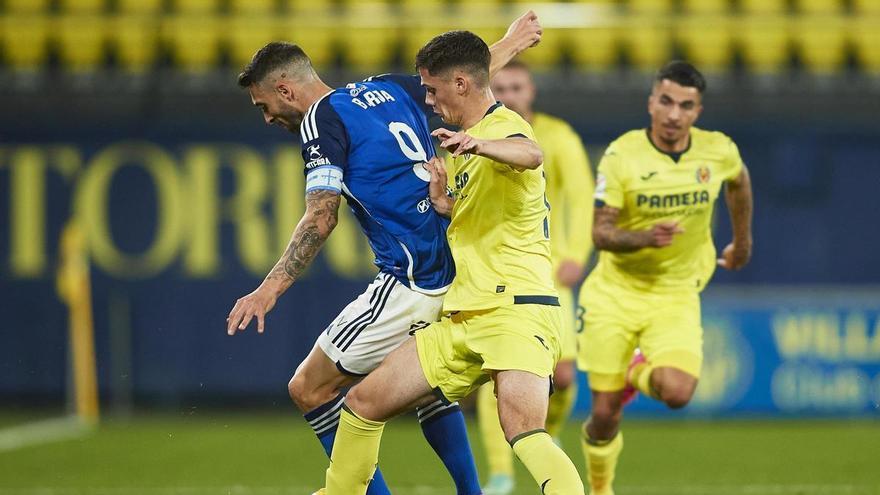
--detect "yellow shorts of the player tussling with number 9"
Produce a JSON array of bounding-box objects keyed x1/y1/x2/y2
[{"x1": 415, "y1": 304, "x2": 562, "y2": 402}]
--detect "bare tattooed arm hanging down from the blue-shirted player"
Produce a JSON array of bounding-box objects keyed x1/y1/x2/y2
[{"x1": 226, "y1": 190, "x2": 340, "y2": 335}]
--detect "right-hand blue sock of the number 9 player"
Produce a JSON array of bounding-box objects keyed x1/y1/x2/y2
[{"x1": 418, "y1": 400, "x2": 482, "y2": 495}]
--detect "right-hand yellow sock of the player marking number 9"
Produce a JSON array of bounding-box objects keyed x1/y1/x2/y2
[{"x1": 511, "y1": 430, "x2": 584, "y2": 495}]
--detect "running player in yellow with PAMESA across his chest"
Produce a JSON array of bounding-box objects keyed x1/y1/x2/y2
[{"x1": 578, "y1": 62, "x2": 752, "y2": 495}]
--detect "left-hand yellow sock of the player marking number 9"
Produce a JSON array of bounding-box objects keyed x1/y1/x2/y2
[{"x1": 326, "y1": 406, "x2": 385, "y2": 495}]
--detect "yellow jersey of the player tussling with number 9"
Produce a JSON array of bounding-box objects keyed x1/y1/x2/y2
[{"x1": 443, "y1": 103, "x2": 557, "y2": 311}]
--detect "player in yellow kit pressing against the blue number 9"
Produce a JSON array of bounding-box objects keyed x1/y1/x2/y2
[{"x1": 318, "y1": 31, "x2": 584, "y2": 495}]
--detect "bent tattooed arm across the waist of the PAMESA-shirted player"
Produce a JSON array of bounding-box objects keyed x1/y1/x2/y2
[{"x1": 593, "y1": 205, "x2": 684, "y2": 253}]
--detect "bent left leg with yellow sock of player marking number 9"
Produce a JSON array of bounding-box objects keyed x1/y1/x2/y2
[{"x1": 326, "y1": 339, "x2": 436, "y2": 495}]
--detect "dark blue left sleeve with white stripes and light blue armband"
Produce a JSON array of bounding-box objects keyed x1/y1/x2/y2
[{"x1": 300, "y1": 98, "x2": 349, "y2": 193}]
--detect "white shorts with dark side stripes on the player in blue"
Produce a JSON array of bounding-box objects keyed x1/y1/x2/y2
[{"x1": 318, "y1": 273, "x2": 443, "y2": 376}]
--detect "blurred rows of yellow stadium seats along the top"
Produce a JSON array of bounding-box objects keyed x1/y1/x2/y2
[{"x1": 0, "y1": 0, "x2": 880, "y2": 74}]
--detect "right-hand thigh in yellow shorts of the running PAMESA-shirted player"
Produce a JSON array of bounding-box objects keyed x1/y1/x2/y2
[{"x1": 639, "y1": 293, "x2": 703, "y2": 377}]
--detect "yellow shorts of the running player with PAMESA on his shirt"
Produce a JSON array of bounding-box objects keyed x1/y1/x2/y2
[{"x1": 578, "y1": 280, "x2": 703, "y2": 391}]
